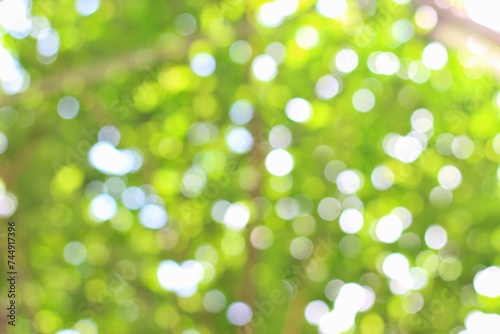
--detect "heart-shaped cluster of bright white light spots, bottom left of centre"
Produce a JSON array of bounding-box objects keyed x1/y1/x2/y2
[{"x1": 156, "y1": 260, "x2": 205, "y2": 297}]
